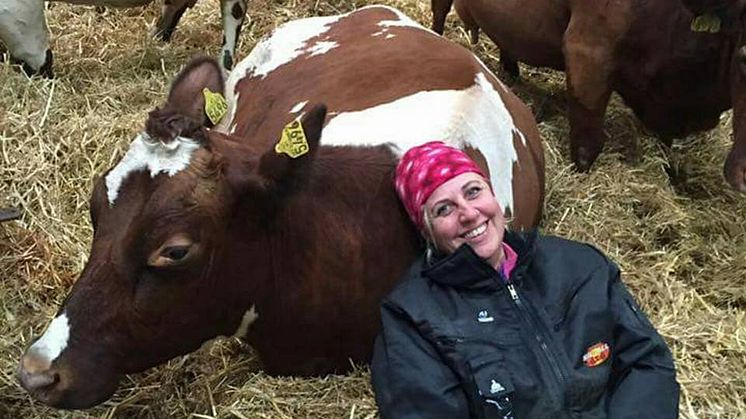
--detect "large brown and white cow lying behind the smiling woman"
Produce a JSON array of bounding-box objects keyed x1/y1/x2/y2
[{"x1": 19, "y1": 6, "x2": 544, "y2": 408}]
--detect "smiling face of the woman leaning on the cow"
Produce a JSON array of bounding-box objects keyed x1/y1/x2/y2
[{"x1": 424, "y1": 173, "x2": 505, "y2": 267}]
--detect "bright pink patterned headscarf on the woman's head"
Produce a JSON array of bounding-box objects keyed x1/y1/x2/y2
[{"x1": 394, "y1": 141, "x2": 485, "y2": 230}]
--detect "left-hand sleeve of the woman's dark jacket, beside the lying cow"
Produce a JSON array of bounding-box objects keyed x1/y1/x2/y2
[{"x1": 371, "y1": 303, "x2": 469, "y2": 419}]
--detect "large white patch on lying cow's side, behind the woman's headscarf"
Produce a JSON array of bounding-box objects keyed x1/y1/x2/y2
[{"x1": 321, "y1": 72, "x2": 526, "y2": 213}]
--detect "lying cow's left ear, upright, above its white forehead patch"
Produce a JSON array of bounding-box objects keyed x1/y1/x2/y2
[{"x1": 166, "y1": 57, "x2": 225, "y2": 126}]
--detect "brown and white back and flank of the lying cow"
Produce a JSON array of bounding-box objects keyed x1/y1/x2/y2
[{"x1": 219, "y1": 6, "x2": 544, "y2": 227}]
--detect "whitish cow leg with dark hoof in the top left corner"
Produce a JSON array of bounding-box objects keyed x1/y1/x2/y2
[{"x1": 0, "y1": 0, "x2": 53, "y2": 77}]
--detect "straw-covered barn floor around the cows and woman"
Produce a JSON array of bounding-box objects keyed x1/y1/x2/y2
[{"x1": 0, "y1": 0, "x2": 746, "y2": 419}]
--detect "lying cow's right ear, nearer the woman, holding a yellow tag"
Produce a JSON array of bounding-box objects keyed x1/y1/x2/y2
[{"x1": 257, "y1": 104, "x2": 326, "y2": 188}]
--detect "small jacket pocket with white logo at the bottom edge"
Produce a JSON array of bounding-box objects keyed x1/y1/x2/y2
[{"x1": 467, "y1": 355, "x2": 516, "y2": 419}]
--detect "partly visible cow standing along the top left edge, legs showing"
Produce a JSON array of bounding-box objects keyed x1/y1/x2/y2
[{"x1": 0, "y1": 0, "x2": 247, "y2": 77}]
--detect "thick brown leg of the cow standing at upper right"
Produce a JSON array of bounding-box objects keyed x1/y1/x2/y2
[{"x1": 563, "y1": 0, "x2": 630, "y2": 171}]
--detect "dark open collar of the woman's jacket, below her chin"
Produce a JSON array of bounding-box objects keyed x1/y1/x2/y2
[{"x1": 422, "y1": 229, "x2": 538, "y2": 288}]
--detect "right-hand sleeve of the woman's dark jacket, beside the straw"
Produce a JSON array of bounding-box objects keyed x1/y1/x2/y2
[{"x1": 608, "y1": 265, "x2": 679, "y2": 419}]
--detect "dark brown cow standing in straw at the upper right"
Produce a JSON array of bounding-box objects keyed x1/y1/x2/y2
[{"x1": 432, "y1": 0, "x2": 746, "y2": 192}]
